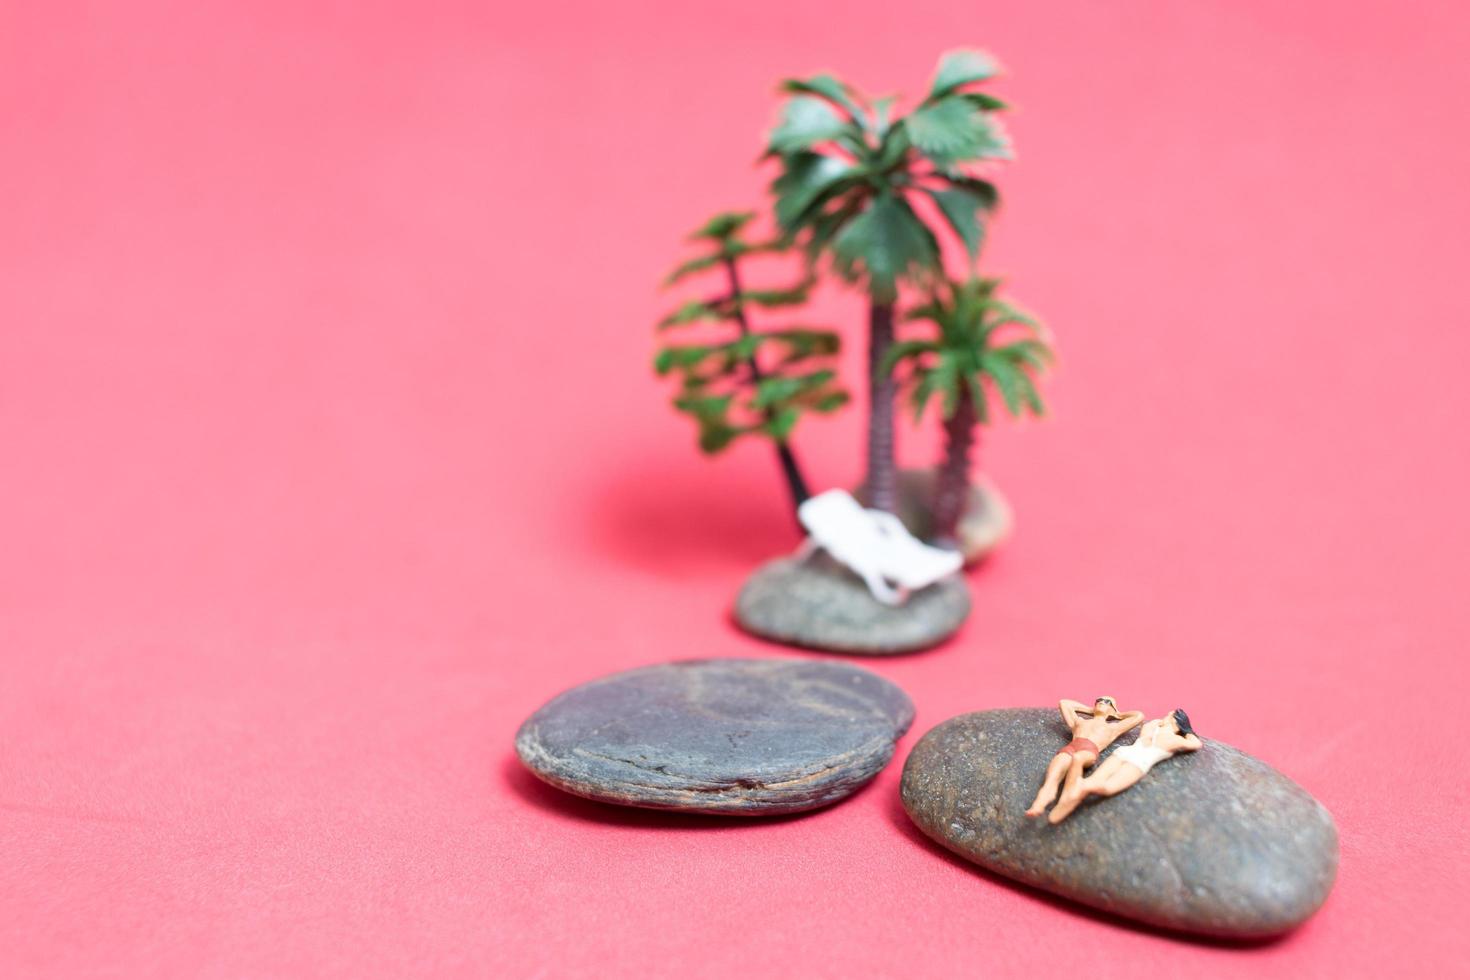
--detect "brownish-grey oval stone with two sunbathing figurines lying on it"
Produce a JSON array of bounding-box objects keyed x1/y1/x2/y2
[{"x1": 901, "y1": 708, "x2": 1338, "y2": 939}]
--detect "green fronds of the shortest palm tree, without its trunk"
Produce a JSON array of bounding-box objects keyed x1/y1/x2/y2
[{"x1": 882, "y1": 279, "x2": 1053, "y2": 423}]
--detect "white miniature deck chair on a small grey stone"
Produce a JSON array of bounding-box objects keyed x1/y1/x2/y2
[{"x1": 797, "y1": 489, "x2": 964, "y2": 605}]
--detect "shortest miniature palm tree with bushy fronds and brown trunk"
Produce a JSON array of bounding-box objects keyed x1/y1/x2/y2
[{"x1": 885, "y1": 279, "x2": 1053, "y2": 542}]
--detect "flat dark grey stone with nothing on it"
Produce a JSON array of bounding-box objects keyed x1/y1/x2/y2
[{"x1": 516, "y1": 660, "x2": 914, "y2": 815}]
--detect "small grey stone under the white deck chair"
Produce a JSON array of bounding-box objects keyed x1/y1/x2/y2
[{"x1": 735, "y1": 552, "x2": 970, "y2": 654}]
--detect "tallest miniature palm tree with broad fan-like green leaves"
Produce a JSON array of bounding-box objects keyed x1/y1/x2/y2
[{"x1": 767, "y1": 51, "x2": 1010, "y2": 511}]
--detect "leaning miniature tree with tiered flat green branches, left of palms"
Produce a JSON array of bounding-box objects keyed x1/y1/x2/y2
[{"x1": 654, "y1": 212, "x2": 848, "y2": 517}]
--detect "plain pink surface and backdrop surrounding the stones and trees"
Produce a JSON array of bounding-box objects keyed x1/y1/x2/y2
[{"x1": 0, "y1": 1, "x2": 1470, "y2": 977}]
